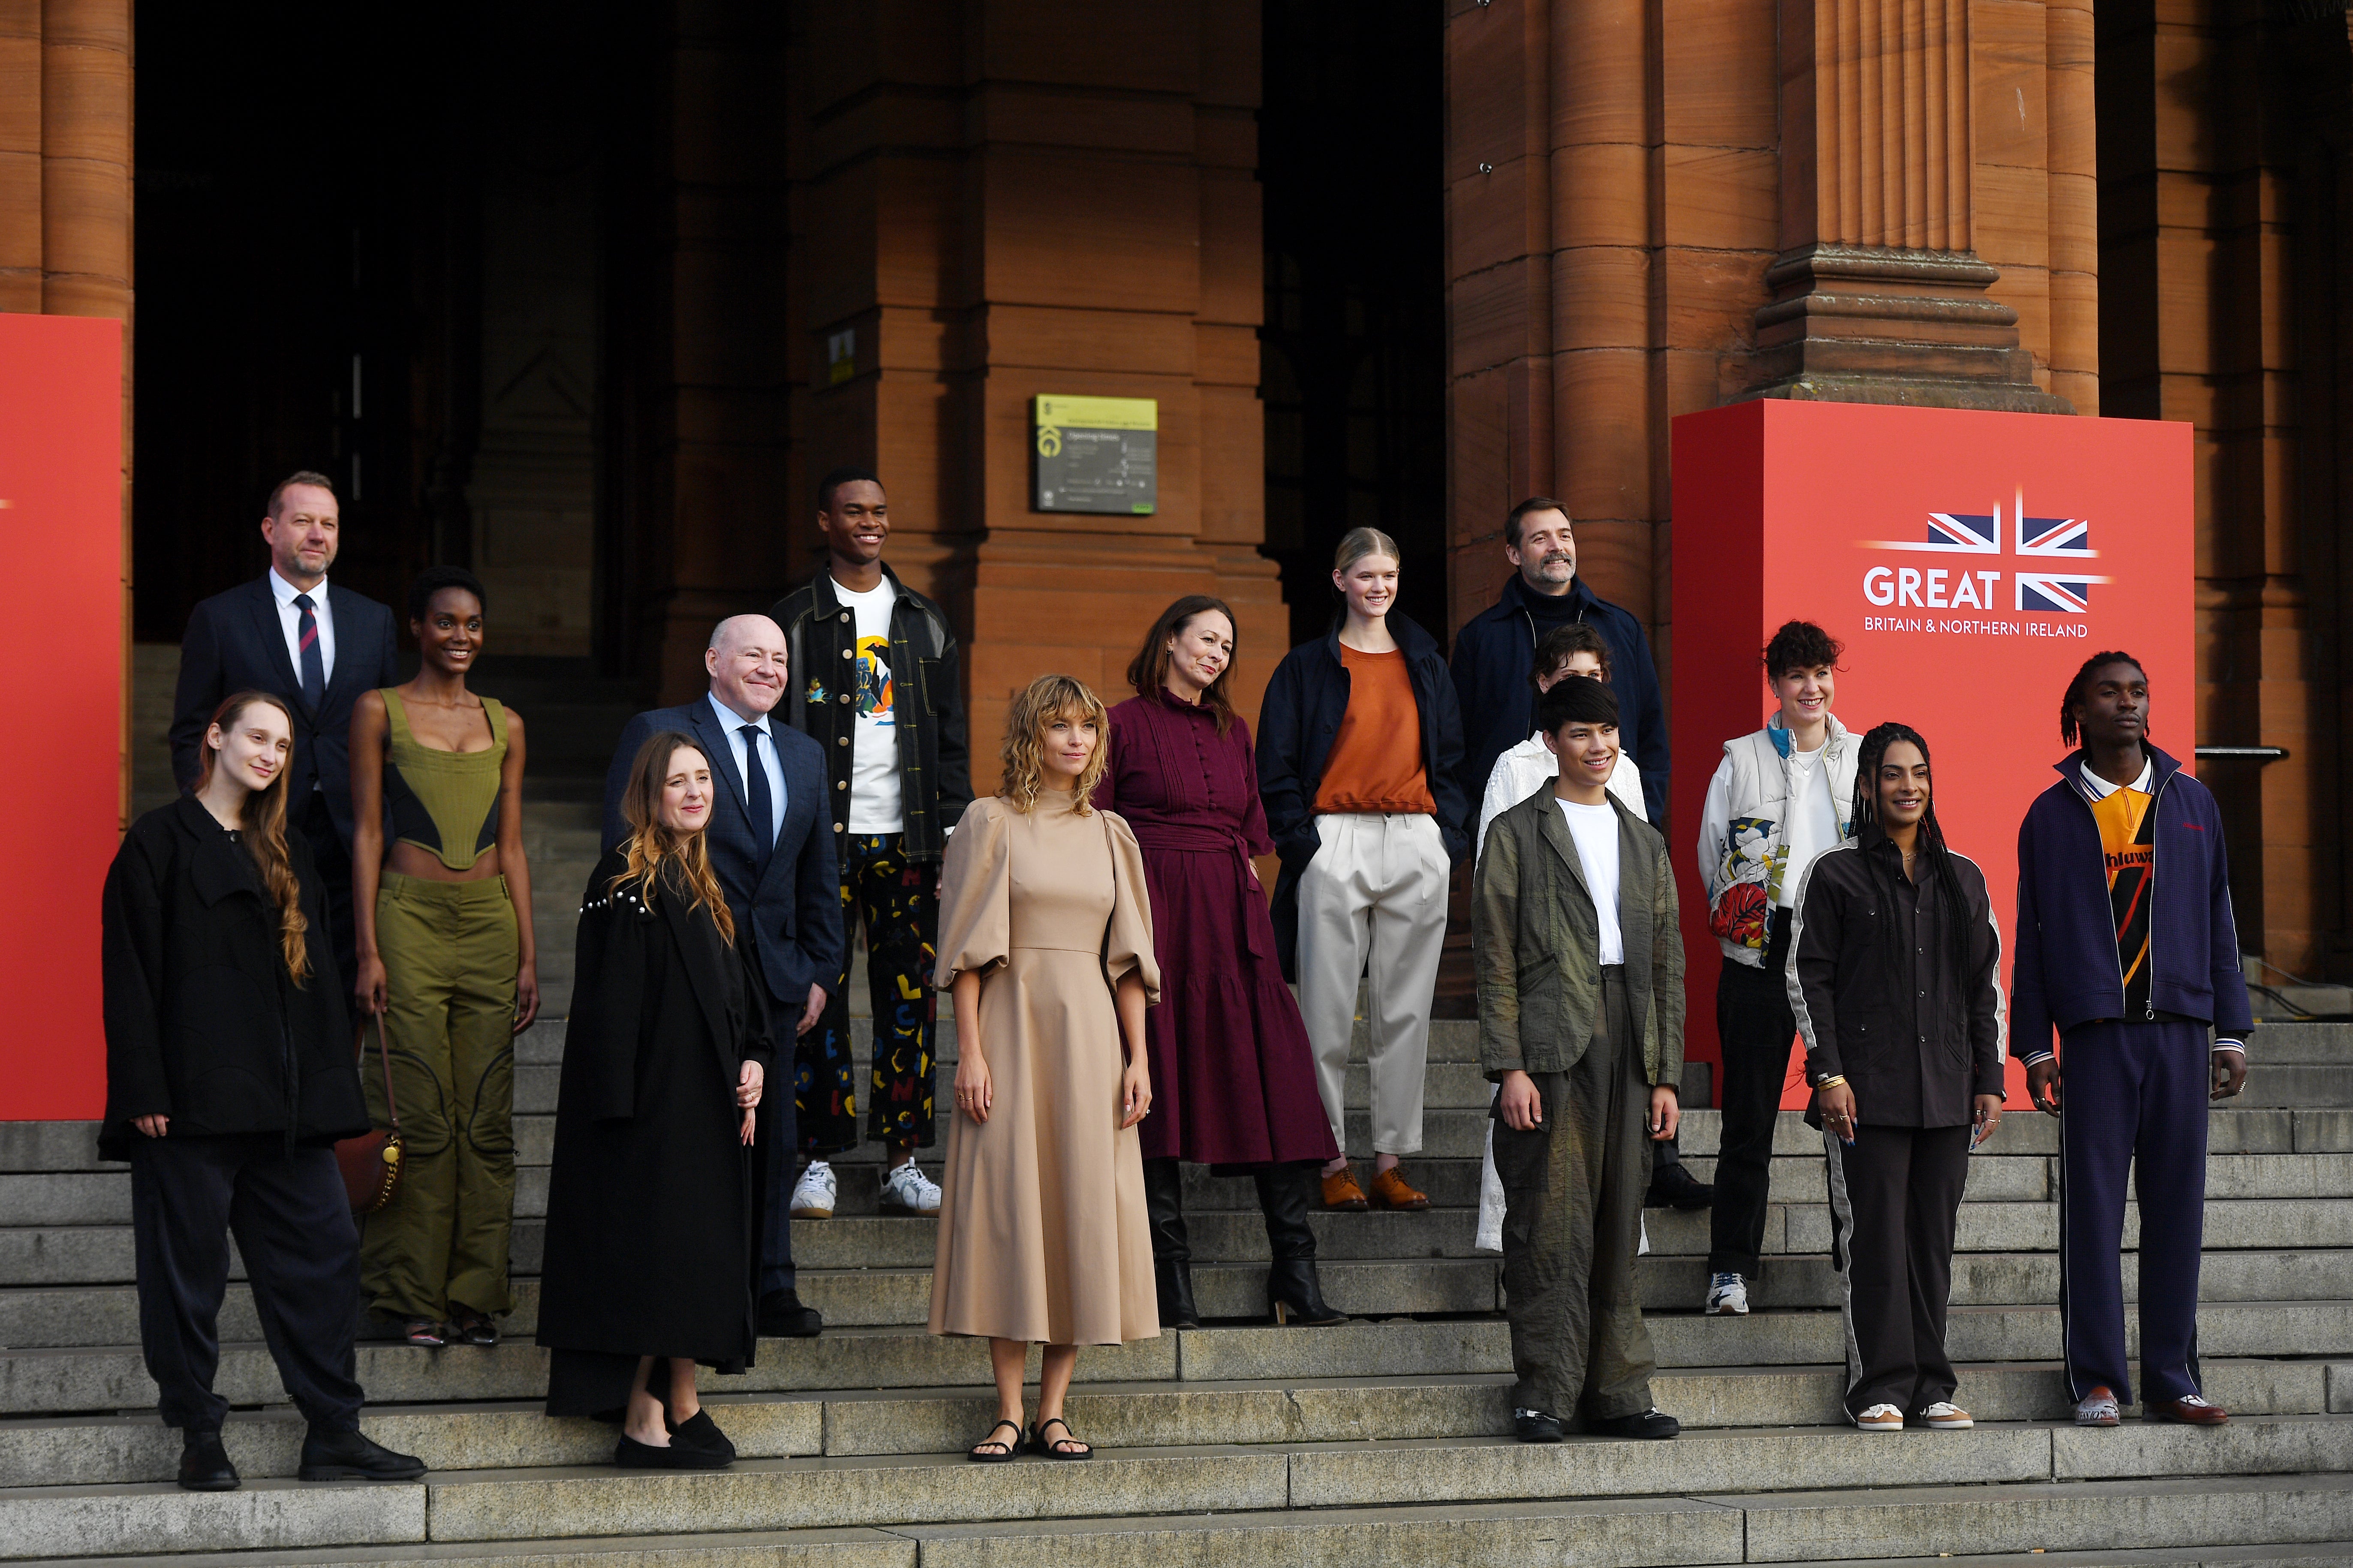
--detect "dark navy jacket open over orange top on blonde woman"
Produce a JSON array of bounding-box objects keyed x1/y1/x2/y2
[{"x1": 1259, "y1": 616, "x2": 1459, "y2": 980}]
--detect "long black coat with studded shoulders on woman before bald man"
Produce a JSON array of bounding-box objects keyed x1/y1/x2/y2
[{"x1": 539, "y1": 851, "x2": 793, "y2": 1370}]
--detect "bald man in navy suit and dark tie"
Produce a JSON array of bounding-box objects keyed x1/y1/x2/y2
[{"x1": 605, "y1": 616, "x2": 845, "y2": 1338}]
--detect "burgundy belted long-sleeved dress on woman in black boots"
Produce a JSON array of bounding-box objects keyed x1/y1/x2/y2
[{"x1": 1094, "y1": 691, "x2": 1339, "y2": 1166}]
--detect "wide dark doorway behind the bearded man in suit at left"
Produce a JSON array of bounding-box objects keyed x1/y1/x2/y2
[{"x1": 132, "y1": 0, "x2": 617, "y2": 658}]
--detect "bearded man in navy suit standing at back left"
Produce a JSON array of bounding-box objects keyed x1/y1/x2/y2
[{"x1": 172, "y1": 470, "x2": 400, "y2": 997}]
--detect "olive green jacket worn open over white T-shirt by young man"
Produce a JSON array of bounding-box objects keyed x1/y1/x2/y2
[{"x1": 1471, "y1": 790, "x2": 1682, "y2": 1088}]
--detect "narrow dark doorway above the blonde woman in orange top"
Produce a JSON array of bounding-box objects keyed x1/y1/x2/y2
[{"x1": 1259, "y1": 0, "x2": 1447, "y2": 642}]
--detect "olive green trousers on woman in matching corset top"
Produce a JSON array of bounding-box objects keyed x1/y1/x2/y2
[{"x1": 360, "y1": 872, "x2": 518, "y2": 1321}]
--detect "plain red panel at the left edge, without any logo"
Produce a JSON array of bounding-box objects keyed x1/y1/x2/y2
[{"x1": 0, "y1": 315, "x2": 122, "y2": 1121}]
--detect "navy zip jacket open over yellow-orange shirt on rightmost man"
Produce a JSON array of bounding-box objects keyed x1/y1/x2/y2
[{"x1": 2012, "y1": 745, "x2": 2254, "y2": 1063}]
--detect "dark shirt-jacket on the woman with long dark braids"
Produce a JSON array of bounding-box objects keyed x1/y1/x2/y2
[{"x1": 1788, "y1": 823, "x2": 2010, "y2": 1126}]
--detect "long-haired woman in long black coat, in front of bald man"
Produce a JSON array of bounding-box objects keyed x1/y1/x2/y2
[{"x1": 539, "y1": 731, "x2": 774, "y2": 1469}]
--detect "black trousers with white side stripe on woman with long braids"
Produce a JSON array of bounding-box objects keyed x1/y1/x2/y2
[{"x1": 1821, "y1": 1112, "x2": 1969, "y2": 1418}]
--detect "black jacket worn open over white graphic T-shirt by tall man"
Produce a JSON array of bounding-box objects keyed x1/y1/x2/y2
[{"x1": 767, "y1": 564, "x2": 972, "y2": 874}]
